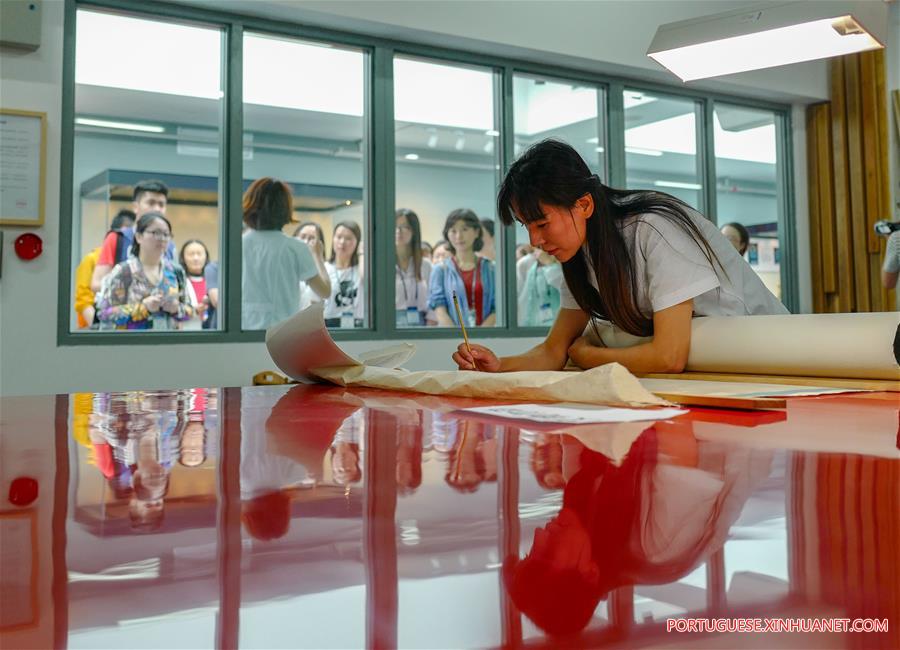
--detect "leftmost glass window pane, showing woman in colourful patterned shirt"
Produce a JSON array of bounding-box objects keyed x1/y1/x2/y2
[{"x1": 70, "y1": 10, "x2": 223, "y2": 332}]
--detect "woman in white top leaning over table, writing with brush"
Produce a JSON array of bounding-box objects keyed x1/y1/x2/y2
[{"x1": 453, "y1": 140, "x2": 787, "y2": 373}]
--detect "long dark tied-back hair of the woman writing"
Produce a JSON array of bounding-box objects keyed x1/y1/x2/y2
[{"x1": 497, "y1": 140, "x2": 724, "y2": 336}]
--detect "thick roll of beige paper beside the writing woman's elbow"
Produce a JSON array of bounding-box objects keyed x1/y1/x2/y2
[{"x1": 586, "y1": 312, "x2": 900, "y2": 380}]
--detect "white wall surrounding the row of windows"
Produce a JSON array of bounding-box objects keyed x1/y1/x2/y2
[{"x1": 7, "y1": 0, "x2": 896, "y2": 395}]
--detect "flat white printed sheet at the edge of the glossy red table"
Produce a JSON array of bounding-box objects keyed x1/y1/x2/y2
[{"x1": 460, "y1": 404, "x2": 687, "y2": 424}]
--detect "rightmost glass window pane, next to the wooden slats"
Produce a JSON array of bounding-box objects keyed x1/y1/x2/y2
[{"x1": 713, "y1": 103, "x2": 781, "y2": 299}]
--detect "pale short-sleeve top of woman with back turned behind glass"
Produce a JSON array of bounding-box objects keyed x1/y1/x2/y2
[{"x1": 241, "y1": 229, "x2": 318, "y2": 330}]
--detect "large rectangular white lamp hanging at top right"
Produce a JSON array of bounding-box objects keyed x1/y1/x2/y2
[{"x1": 647, "y1": 2, "x2": 883, "y2": 81}]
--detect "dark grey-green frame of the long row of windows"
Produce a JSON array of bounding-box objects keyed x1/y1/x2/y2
[{"x1": 57, "y1": 0, "x2": 799, "y2": 347}]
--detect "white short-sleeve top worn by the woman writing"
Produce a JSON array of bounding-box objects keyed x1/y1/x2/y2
[{"x1": 560, "y1": 210, "x2": 788, "y2": 318}]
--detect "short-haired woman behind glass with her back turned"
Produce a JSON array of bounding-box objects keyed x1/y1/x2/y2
[{"x1": 241, "y1": 177, "x2": 332, "y2": 330}]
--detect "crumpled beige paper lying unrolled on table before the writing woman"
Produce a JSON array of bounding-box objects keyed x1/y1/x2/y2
[{"x1": 314, "y1": 363, "x2": 668, "y2": 406}]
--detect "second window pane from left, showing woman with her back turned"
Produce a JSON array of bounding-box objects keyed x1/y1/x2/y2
[{"x1": 241, "y1": 33, "x2": 369, "y2": 330}]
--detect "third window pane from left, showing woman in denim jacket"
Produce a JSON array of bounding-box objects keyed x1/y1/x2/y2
[{"x1": 394, "y1": 57, "x2": 503, "y2": 327}]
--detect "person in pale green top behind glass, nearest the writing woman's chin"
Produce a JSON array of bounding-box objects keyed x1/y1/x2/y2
[{"x1": 516, "y1": 249, "x2": 564, "y2": 327}]
